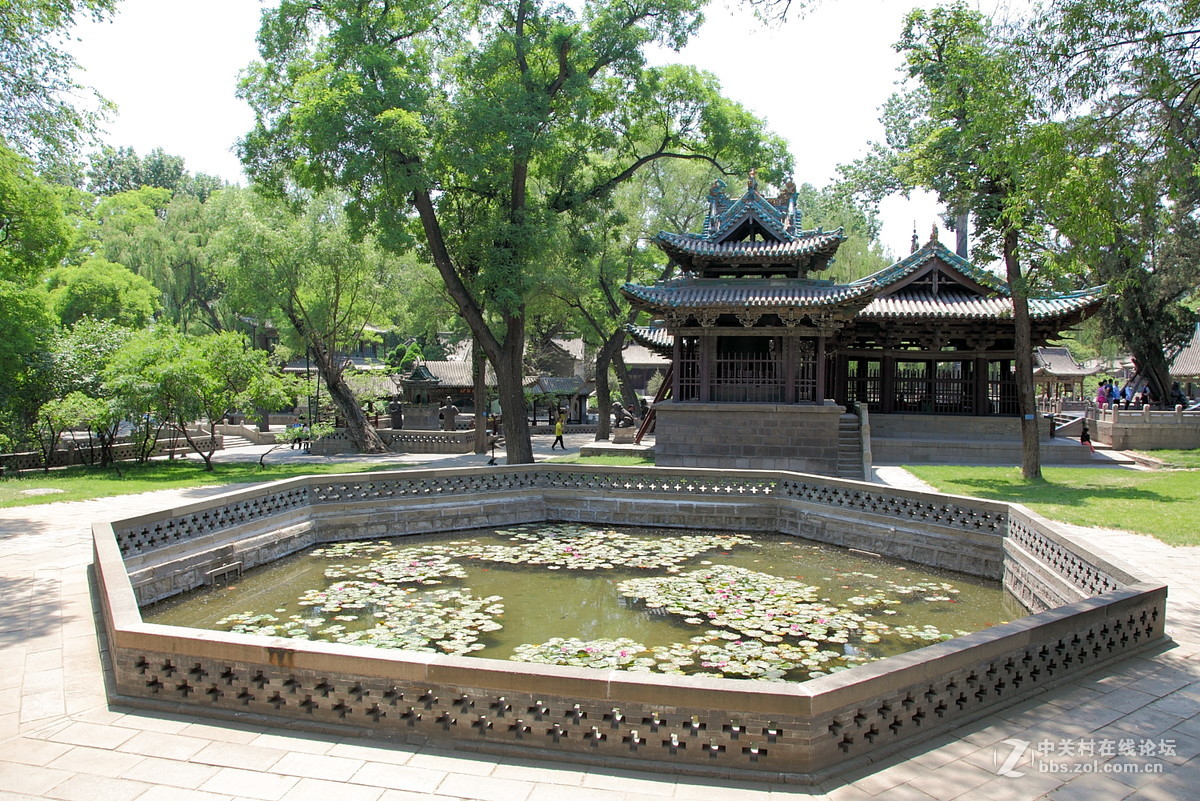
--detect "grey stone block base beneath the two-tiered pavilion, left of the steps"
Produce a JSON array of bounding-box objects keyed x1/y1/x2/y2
[{"x1": 654, "y1": 401, "x2": 846, "y2": 476}]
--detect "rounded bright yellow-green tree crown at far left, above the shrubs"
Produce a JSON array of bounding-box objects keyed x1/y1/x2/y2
[{"x1": 46, "y1": 258, "x2": 162, "y2": 329}]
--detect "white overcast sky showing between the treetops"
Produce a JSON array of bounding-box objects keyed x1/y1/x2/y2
[{"x1": 70, "y1": 0, "x2": 1017, "y2": 258}]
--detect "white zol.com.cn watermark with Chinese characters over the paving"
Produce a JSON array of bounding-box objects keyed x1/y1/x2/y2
[{"x1": 992, "y1": 737, "x2": 1176, "y2": 778}]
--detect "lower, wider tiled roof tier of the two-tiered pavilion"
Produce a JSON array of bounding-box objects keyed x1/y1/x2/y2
[{"x1": 622, "y1": 278, "x2": 874, "y2": 309}]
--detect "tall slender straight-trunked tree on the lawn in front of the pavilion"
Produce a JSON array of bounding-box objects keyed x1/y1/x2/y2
[{"x1": 850, "y1": 1, "x2": 1045, "y2": 478}]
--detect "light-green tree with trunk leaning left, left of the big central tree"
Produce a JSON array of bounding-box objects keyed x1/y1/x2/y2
[{"x1": 215, "y1": 189, "x2": 400, "y2": 453}]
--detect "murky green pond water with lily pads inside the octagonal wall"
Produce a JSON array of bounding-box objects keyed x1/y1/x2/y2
[{"x1": 143, "y1": 523, "x2": 1026, "y2": 680}]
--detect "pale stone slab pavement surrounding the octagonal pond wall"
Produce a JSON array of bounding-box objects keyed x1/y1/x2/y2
[{"x1": 0, "y1": 434, "x2": 1200, "y2": 801}]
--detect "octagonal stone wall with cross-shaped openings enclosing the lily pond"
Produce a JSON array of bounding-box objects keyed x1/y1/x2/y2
[{"x1": 94, "y1": 465, "x2": 1165, "y2": 781}]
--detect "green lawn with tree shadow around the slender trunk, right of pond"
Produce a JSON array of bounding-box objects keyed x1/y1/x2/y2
[{"x1": 905, "y1": 465, "x2": 1200, "y2": 546}]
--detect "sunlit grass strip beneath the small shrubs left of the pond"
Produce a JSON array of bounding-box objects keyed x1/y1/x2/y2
[{"x1": 0, "y1": 459, "x2": 397, "y2": 507}]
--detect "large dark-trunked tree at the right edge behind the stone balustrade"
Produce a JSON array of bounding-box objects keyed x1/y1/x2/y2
[{"x1": 1019, "y1": 0, "x2": 1200, "y2": 401}]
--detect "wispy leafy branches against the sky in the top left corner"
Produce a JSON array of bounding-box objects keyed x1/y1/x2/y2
[{"x1": 0, "y1": 0, "x2": 116, "y2": 163}]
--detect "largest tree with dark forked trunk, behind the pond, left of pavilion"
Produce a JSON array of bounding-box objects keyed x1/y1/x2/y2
[{"x1": 241, "y1": 0, "x2": 780, "y2": 463}]
